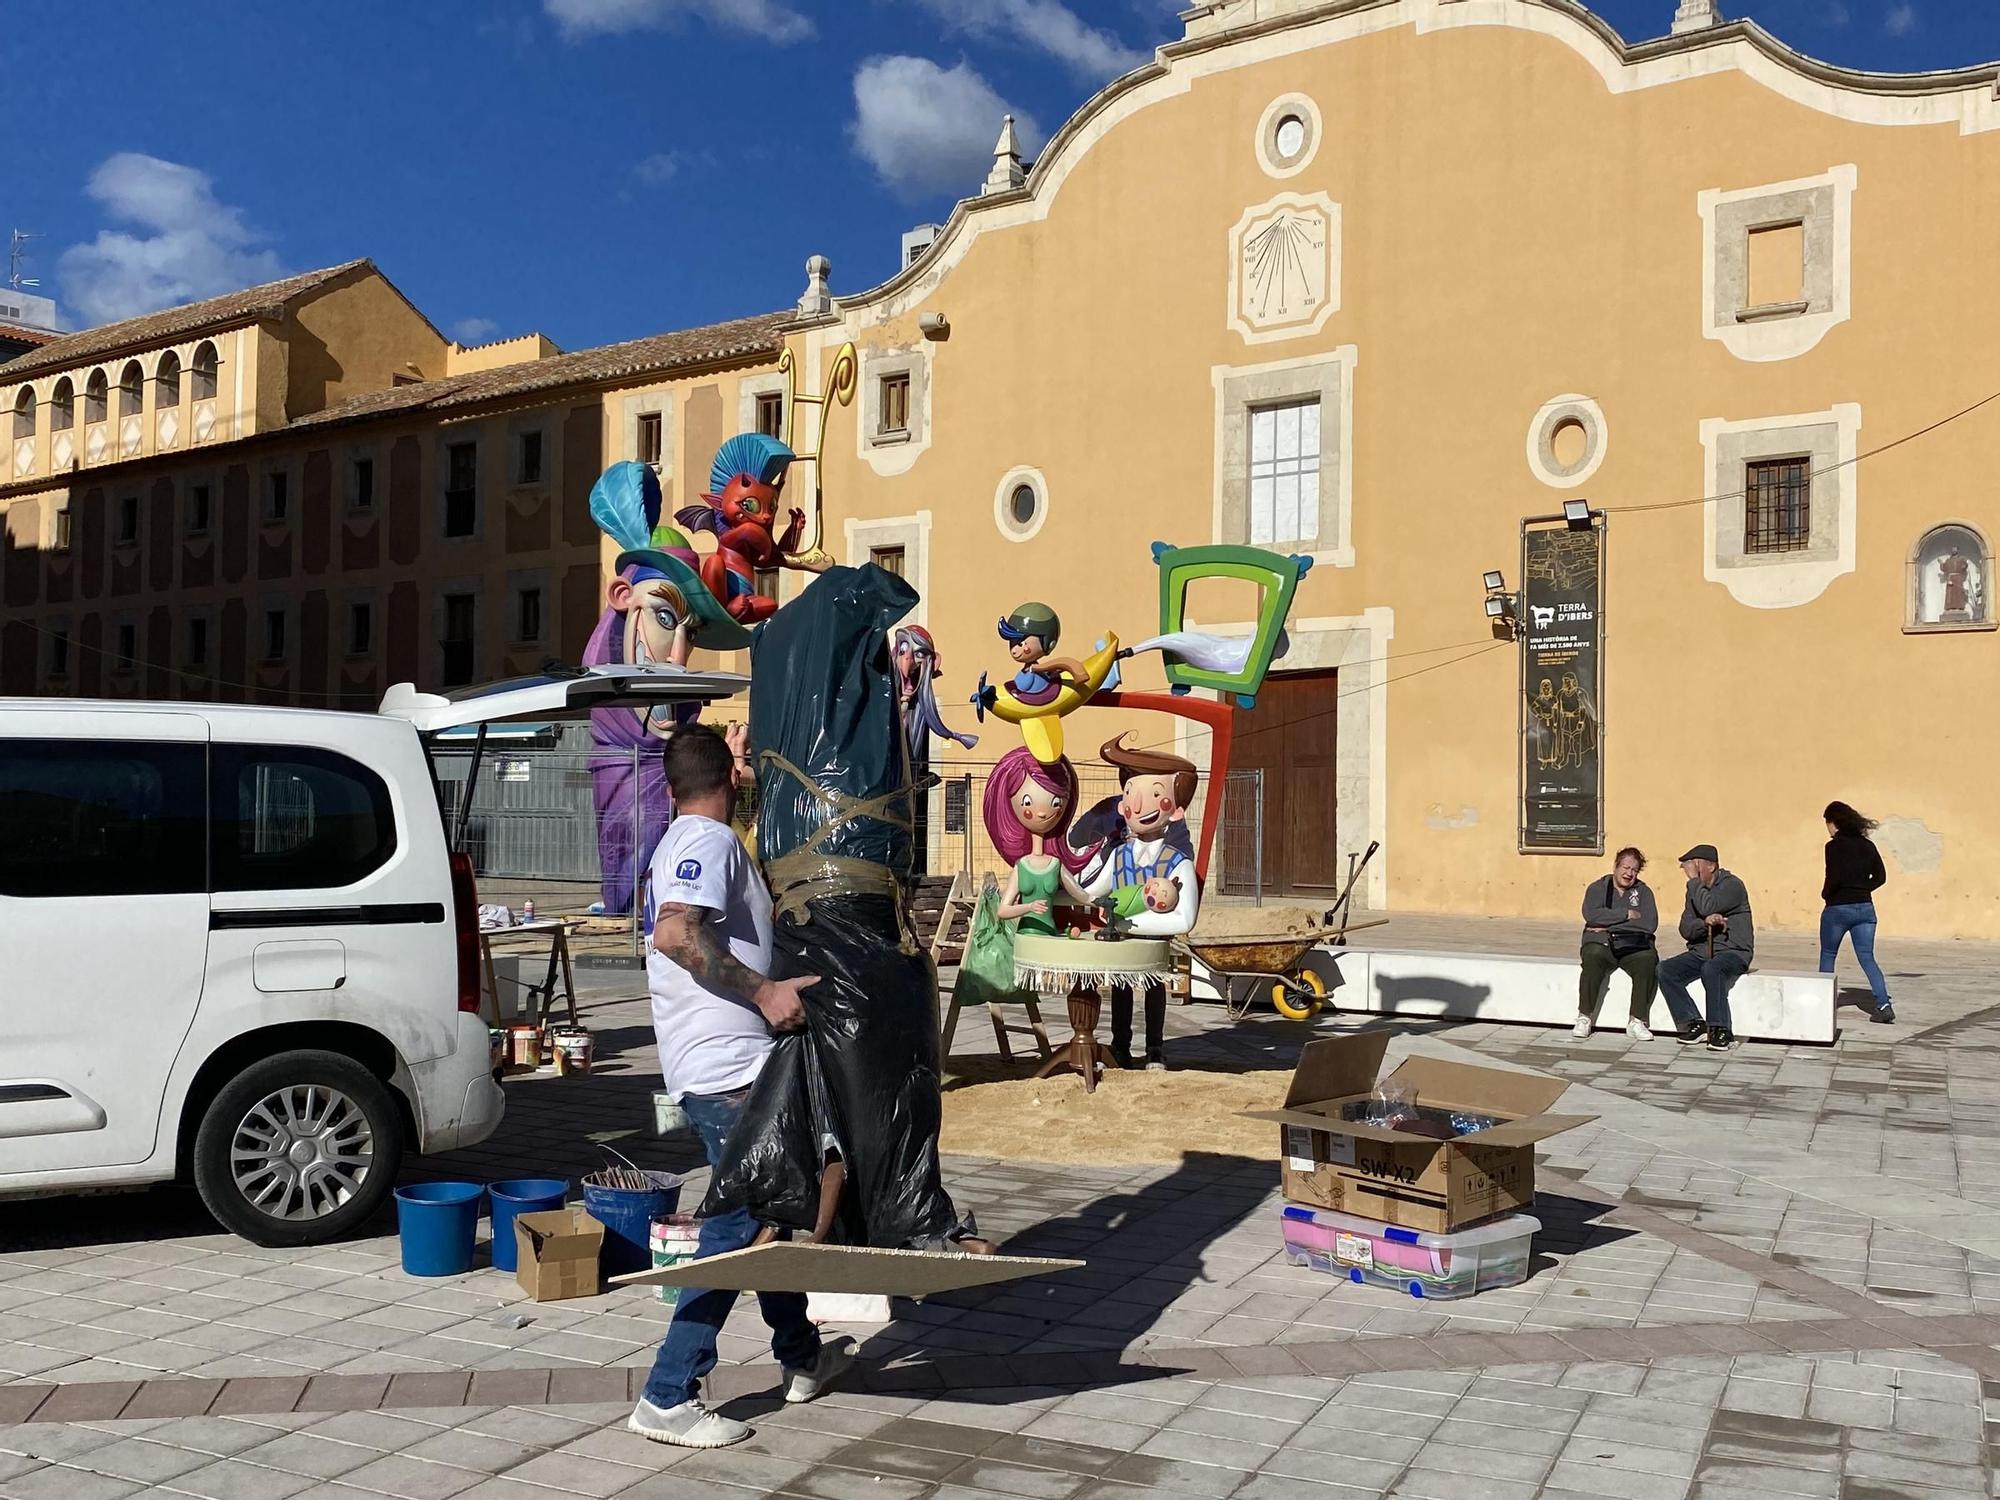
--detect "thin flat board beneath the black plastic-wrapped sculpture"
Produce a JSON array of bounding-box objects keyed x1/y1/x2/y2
[{"x1": 612, "y1": 1240, "x2": 1084, "y2": 1298}]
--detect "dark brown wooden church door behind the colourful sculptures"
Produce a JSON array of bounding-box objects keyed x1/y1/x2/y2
[{"x1": 1226, "y1": 672, "x2": 1340, "y2": 898}]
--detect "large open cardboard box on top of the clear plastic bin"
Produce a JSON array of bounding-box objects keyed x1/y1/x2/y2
[{"x1": 1246, "y1": 1032, "x2": 1596, "y2": 1234}]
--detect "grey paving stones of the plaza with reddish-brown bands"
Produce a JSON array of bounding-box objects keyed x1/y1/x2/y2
[{"x1": 0, "y1": 922, "x2": 2000, "y2": 1500}]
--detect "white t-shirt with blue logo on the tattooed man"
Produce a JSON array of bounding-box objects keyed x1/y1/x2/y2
[{"x1": 646, "y1": 814, "x2": 772, "y2": 1100}]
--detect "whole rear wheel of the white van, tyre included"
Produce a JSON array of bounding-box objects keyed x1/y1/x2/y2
[{"x1": 194, "y1": 1052, "x2": 402, "y2": 1246}]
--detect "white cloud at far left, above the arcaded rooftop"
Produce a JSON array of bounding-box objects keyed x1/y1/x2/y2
[{"x1": 56, "y1": 152, "x2": 282, "y2": 326}]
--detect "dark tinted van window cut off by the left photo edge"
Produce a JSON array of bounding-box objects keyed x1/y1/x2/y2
[{"x1": 0, "y1": 740, "x2": 208, "y2": 896}]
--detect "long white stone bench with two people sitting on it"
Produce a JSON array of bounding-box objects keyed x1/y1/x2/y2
[{"x1": 1192, "y1": 948, "x2": 1834, "y2": 1044}]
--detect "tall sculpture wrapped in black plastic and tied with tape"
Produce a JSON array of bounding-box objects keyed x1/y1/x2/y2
[{"x1": 702, "y1": 564, "x2": 970, "y2": 1250}]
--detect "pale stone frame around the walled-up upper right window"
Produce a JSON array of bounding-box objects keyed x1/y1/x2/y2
[{"x1": 1696, "y1": 162, "x2": 1860, "y2": 364}]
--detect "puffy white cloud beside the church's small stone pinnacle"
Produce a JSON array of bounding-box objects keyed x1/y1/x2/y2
[{"x1": 848, "y1": 56, "x2": 1042, "y2": 196}]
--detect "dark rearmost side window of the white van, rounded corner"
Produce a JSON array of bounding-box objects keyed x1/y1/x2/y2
[{"x1": 210, "y1": 744, "x2": 396, "y2": 890}]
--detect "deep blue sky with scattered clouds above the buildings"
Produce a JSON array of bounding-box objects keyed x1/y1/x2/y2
[{"x1": 0, "y1": 0, "x2": 2000, "y2": 348}]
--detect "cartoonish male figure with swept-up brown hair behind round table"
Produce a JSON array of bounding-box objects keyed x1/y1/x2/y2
[{"x1": 1084, "y1": 734, "x2": 1200, "y2": 1070}]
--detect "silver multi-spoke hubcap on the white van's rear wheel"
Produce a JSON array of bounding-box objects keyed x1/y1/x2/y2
[{"x1": 230, "y1": 1084, "x2": 374, "y2": 1218}]
